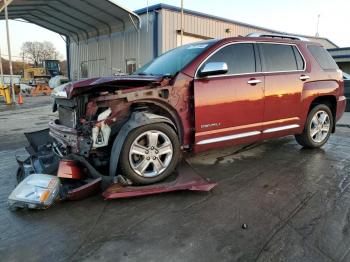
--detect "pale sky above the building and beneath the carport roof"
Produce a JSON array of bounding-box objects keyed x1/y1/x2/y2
[{"x1": 0, "y1": 0, "x2": 350, "y2": 59}]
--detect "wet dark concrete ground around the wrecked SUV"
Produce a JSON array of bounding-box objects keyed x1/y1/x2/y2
[{"x1": 0, "y1": 98, "x2": 350, "y2": 262}]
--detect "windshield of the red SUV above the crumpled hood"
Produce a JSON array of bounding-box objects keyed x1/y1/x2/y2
[{"x1": 134, "y1": 40, "x2": 217, "y2": 76}]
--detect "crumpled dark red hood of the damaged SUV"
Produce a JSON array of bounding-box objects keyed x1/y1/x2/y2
[{"x1": 54, "y1": 75, "x2": 164, "y2": 98}]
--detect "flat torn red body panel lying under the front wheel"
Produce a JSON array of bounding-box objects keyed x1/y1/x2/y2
[{"x1": 102, "y1": 161, "x2": 217, "y2": 199}]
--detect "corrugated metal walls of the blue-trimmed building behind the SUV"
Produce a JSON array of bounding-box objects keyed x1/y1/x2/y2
[{"x1": 70, "y1": 8, "x2": 333, "y2": 80}]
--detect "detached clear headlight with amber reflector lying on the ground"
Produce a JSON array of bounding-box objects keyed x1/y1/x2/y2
[{"x1": 8, "y1": 174, "x2": 60, "y2": 209}]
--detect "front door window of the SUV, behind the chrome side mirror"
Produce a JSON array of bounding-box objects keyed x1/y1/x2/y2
[{"x1": 202, "y1": 43, "x2": 256, "y2": 75}]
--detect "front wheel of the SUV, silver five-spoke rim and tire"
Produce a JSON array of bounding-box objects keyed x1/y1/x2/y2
[{"x1": 120, "y1": 123, "x2": 180, "y2": 185}]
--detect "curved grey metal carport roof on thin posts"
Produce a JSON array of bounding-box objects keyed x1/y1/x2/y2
[{"x1": 0, "y1": 0, "x2": 141, "y2": 40}]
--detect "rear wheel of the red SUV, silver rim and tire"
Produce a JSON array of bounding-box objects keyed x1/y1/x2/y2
[{"x1": 295, "y1": 104, "x2": 334, "y2": 148}]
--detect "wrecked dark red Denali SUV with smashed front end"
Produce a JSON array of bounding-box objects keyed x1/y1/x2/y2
[{"x1": 50, "y1": 35, "x2": 346, "y2": 184}]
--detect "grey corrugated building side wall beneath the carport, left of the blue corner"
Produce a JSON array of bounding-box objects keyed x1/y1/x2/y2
[{"x1": 70, "y1": 14, "x2": 154, "y2": 80}]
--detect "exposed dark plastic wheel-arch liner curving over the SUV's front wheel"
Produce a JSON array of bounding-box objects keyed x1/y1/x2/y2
[{"x1": 109, "y1": 112, "x2": 177, "y2": 177}]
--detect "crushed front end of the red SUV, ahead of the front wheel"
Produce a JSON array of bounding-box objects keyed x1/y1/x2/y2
[{"x1": 49, "y1": 76, "x2": 168, "y2": 176}]
